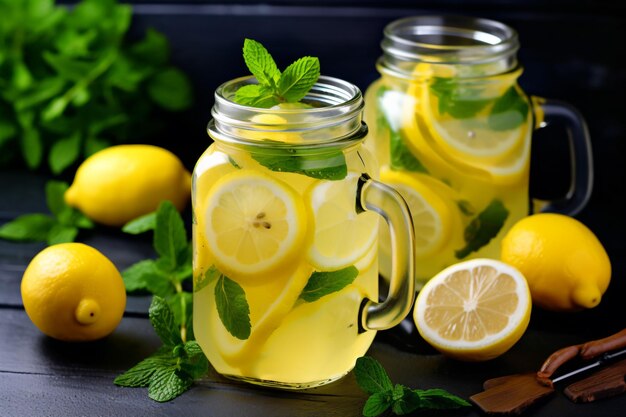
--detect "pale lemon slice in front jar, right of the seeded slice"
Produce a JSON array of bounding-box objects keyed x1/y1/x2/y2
[{"x1": 307, "y1": 173, "x2": 378, "y2": 271}]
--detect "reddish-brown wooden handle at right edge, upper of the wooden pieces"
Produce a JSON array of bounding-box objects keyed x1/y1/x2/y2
[{"x1": 537, "y1": 329, "x2": 626, "y2": 386}]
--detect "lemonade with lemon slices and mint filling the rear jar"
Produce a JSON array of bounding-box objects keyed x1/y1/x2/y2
[{"x1": 366, "y1": 73, "x2": 531, "y2": 282}]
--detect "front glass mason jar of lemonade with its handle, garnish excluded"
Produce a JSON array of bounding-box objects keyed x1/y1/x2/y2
[{"x1": 192, "y1": 77, "x2": 414, "y2": 389}]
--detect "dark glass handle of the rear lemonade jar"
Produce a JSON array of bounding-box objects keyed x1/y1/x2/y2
[{"x1": 532, "y1": 97, "x2": 593, "y2": 216}]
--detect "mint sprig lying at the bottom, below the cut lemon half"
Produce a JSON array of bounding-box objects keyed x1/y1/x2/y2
[{"x1": 354, "y1": 356, "x2": 470, "y2": 417}]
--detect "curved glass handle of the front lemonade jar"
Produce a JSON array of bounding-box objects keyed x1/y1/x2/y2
[{"x1": 357, "y1": 174, "x2": 415, "y2": 330}]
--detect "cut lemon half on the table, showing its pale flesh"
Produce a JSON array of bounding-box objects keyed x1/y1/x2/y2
[{"x1": 413, "y1": 259, "x2": 531, "y2": 361}]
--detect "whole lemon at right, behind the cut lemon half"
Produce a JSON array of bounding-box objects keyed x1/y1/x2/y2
[{"x1": 501, "y1": 213, "x2": 611, "y2": 311}]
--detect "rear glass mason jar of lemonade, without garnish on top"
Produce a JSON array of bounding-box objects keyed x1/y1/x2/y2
[{"x1": 365, "y1": 16, "x2": 592, "y2": 287}]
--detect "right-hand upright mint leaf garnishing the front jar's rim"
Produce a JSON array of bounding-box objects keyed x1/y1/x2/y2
[{"x1": 278, "y1": 56, "x2": 320, "y2": 103}]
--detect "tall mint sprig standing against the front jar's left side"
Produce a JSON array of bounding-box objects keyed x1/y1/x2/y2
[{"x1": 114, "y1": 201, "x2": 209, "y2": 402}]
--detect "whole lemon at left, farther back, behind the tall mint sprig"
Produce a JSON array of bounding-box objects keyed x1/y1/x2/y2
[{"x1": 65, "y1": 145, "x2": 191, "y2": 226}]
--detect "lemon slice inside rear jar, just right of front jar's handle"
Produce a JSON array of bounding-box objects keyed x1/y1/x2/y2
[{"x1": 380, "y1": 168, "x2": 452, "y2": 257}]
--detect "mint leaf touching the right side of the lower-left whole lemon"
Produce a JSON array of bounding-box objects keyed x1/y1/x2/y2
[{"x1": 122, "y1": 259, "x2": 174, "y2": 297}]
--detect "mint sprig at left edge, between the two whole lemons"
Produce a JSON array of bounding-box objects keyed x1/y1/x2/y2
[{"x1": 0, "y1": 181, "x2": 94, "y2": 245}]
